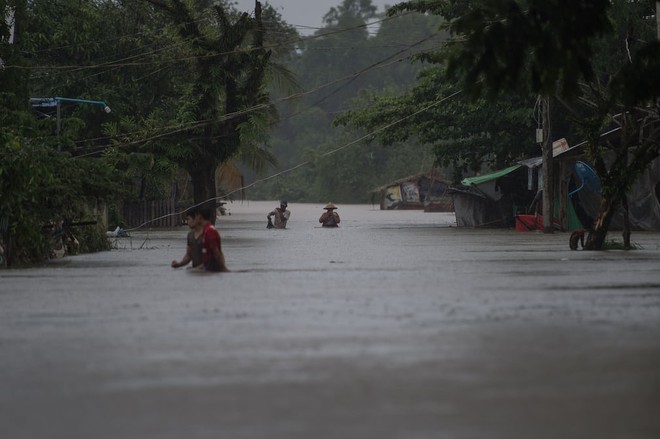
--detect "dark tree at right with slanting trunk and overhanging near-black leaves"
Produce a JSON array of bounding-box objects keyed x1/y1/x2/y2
[{"x1": 356, "y1": 0, "x2": 660, "y2": 249}]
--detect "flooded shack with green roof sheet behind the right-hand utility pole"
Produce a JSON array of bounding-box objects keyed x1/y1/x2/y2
[{"x1": 450, "y1": 141, "x2": 660, "y2": 230}]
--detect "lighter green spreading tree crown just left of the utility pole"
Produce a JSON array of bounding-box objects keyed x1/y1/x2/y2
[{"x1": 335, "y1": 62, "x2": 534, "y2": 181}]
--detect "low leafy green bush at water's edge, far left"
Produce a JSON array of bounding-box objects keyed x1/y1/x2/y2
[{"x1": 0, "y1": 130, "x2": 121, "y2": 265}]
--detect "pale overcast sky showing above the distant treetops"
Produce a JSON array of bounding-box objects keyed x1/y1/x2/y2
[{"x1": 233, "y1": 0, "x2": 392, "y2": 35}]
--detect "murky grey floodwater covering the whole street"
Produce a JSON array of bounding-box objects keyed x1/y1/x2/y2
[{"x1": 0, "y1": 202, "x2": 660, "y2": 439}]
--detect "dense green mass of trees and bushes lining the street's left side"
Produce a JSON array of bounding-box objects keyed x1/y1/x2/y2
[{"x1": 0, "y1": 0, "x2": 286, "y2": 263}]
